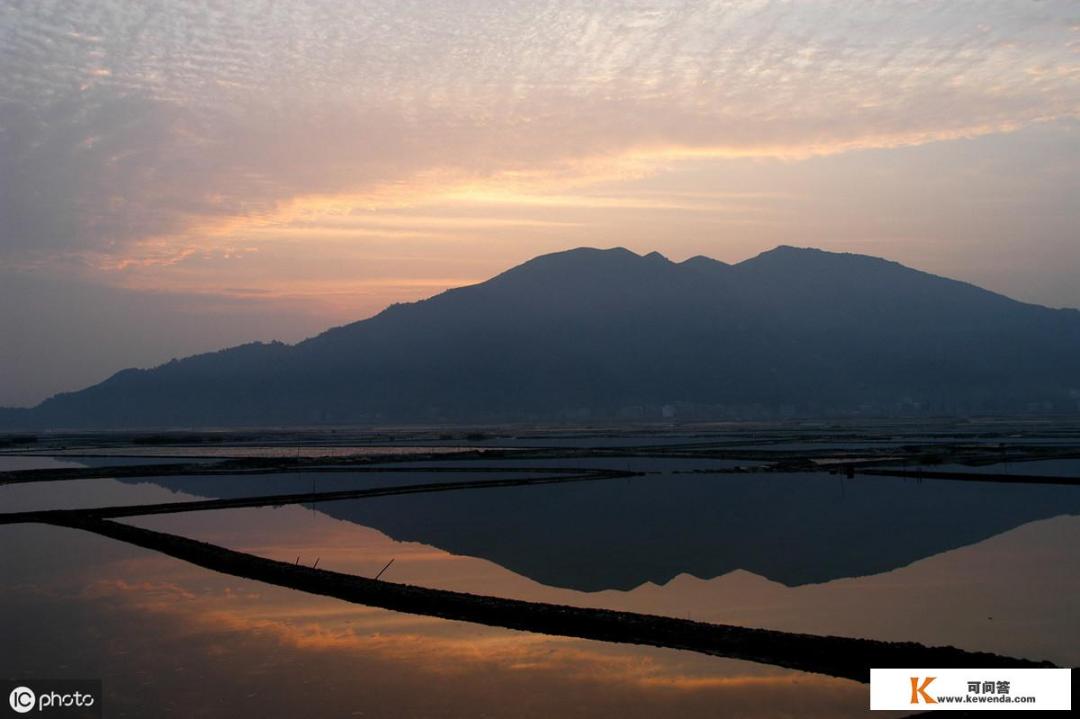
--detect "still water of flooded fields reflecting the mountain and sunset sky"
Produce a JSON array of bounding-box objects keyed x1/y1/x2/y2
[{"x1": 0, "y1": 436, "x2": 1080, "y2": 717}]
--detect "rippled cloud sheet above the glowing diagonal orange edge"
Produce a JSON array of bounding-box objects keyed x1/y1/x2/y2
[{"x1": 0, "y1": 0, "x2": 1080, "y2": 267}]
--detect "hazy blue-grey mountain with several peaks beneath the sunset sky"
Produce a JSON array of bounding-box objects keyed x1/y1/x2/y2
[{"x1": 0, "y1": 246, "x2": 1080, "y2": 428}]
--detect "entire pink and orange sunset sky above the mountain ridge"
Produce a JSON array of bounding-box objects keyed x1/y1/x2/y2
[{"x1": 0, "y1": 0, "x2": 1080, "y2": 406}]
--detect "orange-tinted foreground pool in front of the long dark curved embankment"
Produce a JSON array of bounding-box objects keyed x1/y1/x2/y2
[{"x1": 0, "y1": 520, "x2": 867, "y2": 717}]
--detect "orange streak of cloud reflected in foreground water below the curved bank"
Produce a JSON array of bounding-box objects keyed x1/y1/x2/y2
[{"x1": 79, "y1": 565, "x2": 854, "y2": 694}]
